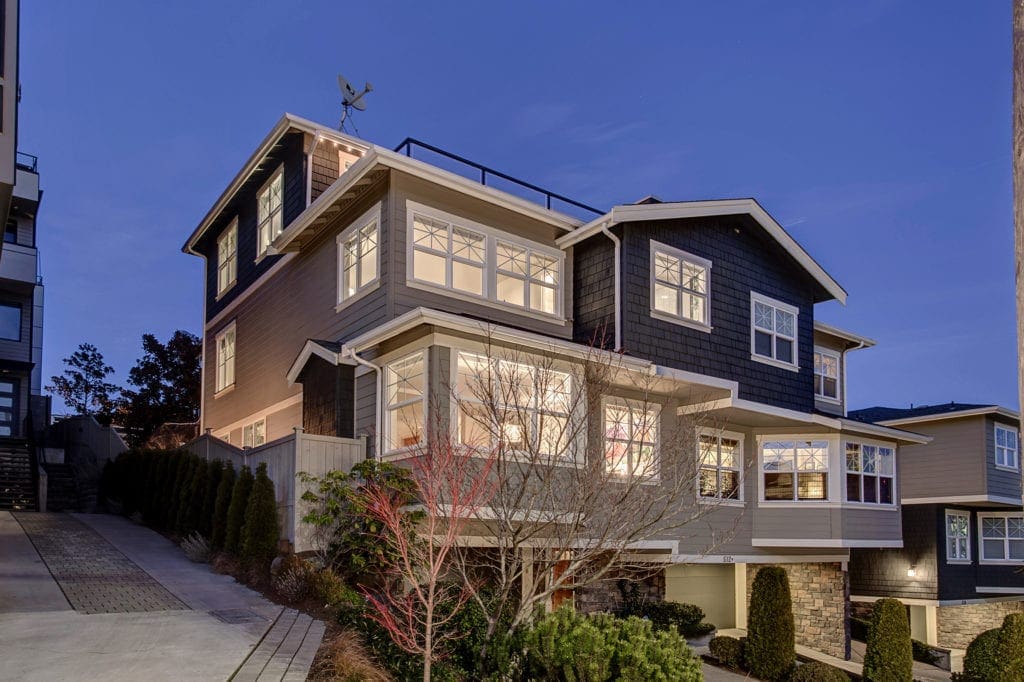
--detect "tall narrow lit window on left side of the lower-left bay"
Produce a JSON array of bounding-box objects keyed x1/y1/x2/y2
[{"x1": 384, "y1": 350, "x2": 427, "y2": 452}]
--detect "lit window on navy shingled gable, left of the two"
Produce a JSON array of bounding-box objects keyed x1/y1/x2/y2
[{"x1": 650, "y1": 242, "x2": 711, "y2": 327}]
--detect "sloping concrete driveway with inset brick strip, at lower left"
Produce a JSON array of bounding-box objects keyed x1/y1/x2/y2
[{"x1": 0, "y1": 512, "x2": 323, "y2": 680}]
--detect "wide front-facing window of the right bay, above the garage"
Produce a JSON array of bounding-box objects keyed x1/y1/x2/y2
[{"x1": 761, "y1": 440, "x2": 828, "y2": 501}]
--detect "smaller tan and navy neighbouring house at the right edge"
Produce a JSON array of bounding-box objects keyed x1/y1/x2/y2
[{"x1": 850, "y1": 402, "x2": 1024, "y2": 648}]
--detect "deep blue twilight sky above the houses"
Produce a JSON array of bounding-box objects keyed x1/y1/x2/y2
[{"x1": 19, "y1": 0, "x2": 1017, "y2": 407}]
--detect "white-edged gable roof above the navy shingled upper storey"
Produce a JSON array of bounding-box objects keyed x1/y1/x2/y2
[{"x1": 557, "y1": 199, "x2": 847, "y2": 304}]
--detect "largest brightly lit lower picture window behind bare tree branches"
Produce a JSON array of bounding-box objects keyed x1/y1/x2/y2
[{"x1": 456, "y1": 351, "x2": 573, "y2": 458}]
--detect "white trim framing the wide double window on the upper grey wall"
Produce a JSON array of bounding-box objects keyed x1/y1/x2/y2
[{"x1": 406, "y1": 201, "x2": 571, "y2": 323}]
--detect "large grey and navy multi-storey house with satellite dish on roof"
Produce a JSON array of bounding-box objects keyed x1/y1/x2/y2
[{"x1": 183, "y1": 115, "x2": 927, "y2": 656}]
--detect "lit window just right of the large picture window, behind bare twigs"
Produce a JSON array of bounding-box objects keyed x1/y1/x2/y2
[{"x1": 604, "y1": 400, "x2": 659, "y2": 478}]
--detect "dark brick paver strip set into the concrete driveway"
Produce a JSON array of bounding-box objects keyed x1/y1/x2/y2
[{"x1": 14, "y1": 513, "x2": 188, "y2": 613}]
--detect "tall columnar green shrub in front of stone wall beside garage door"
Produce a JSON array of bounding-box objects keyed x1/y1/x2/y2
[{"x1": 743, "y1": 566, "x2": 797, "y2": 680}]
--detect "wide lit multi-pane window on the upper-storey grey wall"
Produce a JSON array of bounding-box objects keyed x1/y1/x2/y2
[{"x1": 409, "y1": 202, "x2": 564, "y2": 316}]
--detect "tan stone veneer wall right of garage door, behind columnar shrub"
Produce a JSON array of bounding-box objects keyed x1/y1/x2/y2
[{"x1": 746, "y1": 563, "x2": 850, "y2": 658}]
